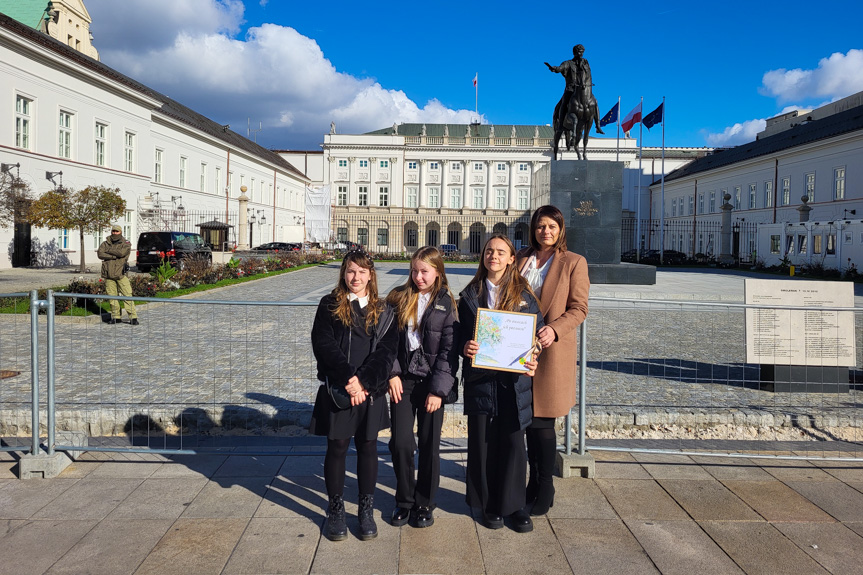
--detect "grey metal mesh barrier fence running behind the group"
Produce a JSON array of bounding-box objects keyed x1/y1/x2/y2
[{"x1": 0, "y1": 291, "x2": 863, "y2": 472}]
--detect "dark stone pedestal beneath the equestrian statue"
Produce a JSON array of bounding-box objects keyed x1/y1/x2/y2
[{"x1": 531, "y1": 160, "x2": 656, "y2": 284}]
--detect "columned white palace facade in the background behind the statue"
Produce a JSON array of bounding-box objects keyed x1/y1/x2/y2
[{"x1": 279, "y1": 124, "x2": 709, "y2": 253}]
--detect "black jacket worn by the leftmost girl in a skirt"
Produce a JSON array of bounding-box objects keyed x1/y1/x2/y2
[{"x1": 312, "y1": 294, "x2": 399, "y2": 397}]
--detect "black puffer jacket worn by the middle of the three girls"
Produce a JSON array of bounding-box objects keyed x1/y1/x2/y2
[{"x1": 391, "y1": 290, "x2": 458, "y2": 397}]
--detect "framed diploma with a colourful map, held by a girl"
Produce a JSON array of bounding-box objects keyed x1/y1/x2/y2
[{"x1": 471, "y1": 307, "x2": 536, "y2": 373}]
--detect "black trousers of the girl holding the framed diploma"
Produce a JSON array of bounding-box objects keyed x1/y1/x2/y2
[{"x1": 467, "y1": 382, "x2": 527, "y2": 515}]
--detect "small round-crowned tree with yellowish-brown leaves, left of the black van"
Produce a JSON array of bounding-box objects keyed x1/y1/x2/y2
[{"x1": 30, "y1": 186, "x2": 126, "y2": 273}]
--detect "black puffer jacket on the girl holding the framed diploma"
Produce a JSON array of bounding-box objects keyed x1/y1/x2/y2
[{"x1": 458, "y1": 286, "x2": 545, "y2": 429}]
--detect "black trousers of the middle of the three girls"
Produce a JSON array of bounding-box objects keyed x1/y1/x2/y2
[{"x1": 390, "y1": 377, "x2": 444, "y2": 509}]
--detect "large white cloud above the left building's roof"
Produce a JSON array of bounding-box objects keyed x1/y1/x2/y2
[{"x1": 88, "y1": 0, "x2": 472, "y2": 148}]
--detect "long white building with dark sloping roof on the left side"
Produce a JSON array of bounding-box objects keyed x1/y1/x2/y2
[{"x1": 0, "y1": 0, "x2": 311, "y2": 269}]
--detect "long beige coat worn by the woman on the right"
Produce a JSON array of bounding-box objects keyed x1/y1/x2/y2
[{"x1": 516, "y1": 248, "x2": 590, "y2": 417}]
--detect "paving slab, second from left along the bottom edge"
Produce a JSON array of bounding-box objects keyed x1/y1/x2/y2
[{"x1": 47, "y1": 519, "x2": 173, "y2": 575}]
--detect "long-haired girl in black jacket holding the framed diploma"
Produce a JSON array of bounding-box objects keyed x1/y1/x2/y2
[{"x1": 458, "y1": 234, "x2": 544, "y2": 533}]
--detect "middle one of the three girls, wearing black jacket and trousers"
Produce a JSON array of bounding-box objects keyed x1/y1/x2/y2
[{"x1": 387, "y1": 246, "x2": 458, "y2": 527}]
